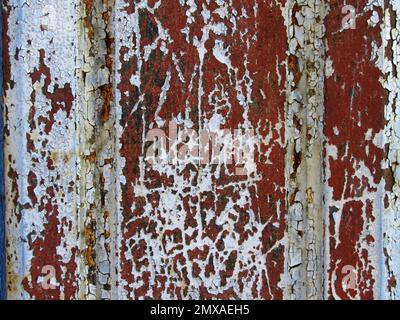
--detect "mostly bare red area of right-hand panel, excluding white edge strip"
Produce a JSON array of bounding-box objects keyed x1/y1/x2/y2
[{"x1": 324, "y1": 1, "x2": 386, "y2": 299}]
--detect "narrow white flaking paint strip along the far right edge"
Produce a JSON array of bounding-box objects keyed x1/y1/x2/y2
[{"x1": 376, "y1": 1, "x2": 400, "y2": 299}]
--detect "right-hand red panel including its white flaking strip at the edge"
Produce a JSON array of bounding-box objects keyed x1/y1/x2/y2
[{"x1": 324, "y1": 1, "x2": 399, "y2": 299}]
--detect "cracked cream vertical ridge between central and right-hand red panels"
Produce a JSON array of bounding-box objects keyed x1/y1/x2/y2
[{"x1": 286, "y1": 0, "x2": 325, "y2": 299}]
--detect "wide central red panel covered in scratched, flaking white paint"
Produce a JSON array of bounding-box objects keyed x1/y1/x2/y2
[{"x1": 116, "y1": 1, "x2": 285, "y2": 299}]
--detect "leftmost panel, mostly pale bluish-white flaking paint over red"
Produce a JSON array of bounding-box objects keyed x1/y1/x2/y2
[{"x1": 3, "y1": 1, "x2": 78, "y2": 299}]
